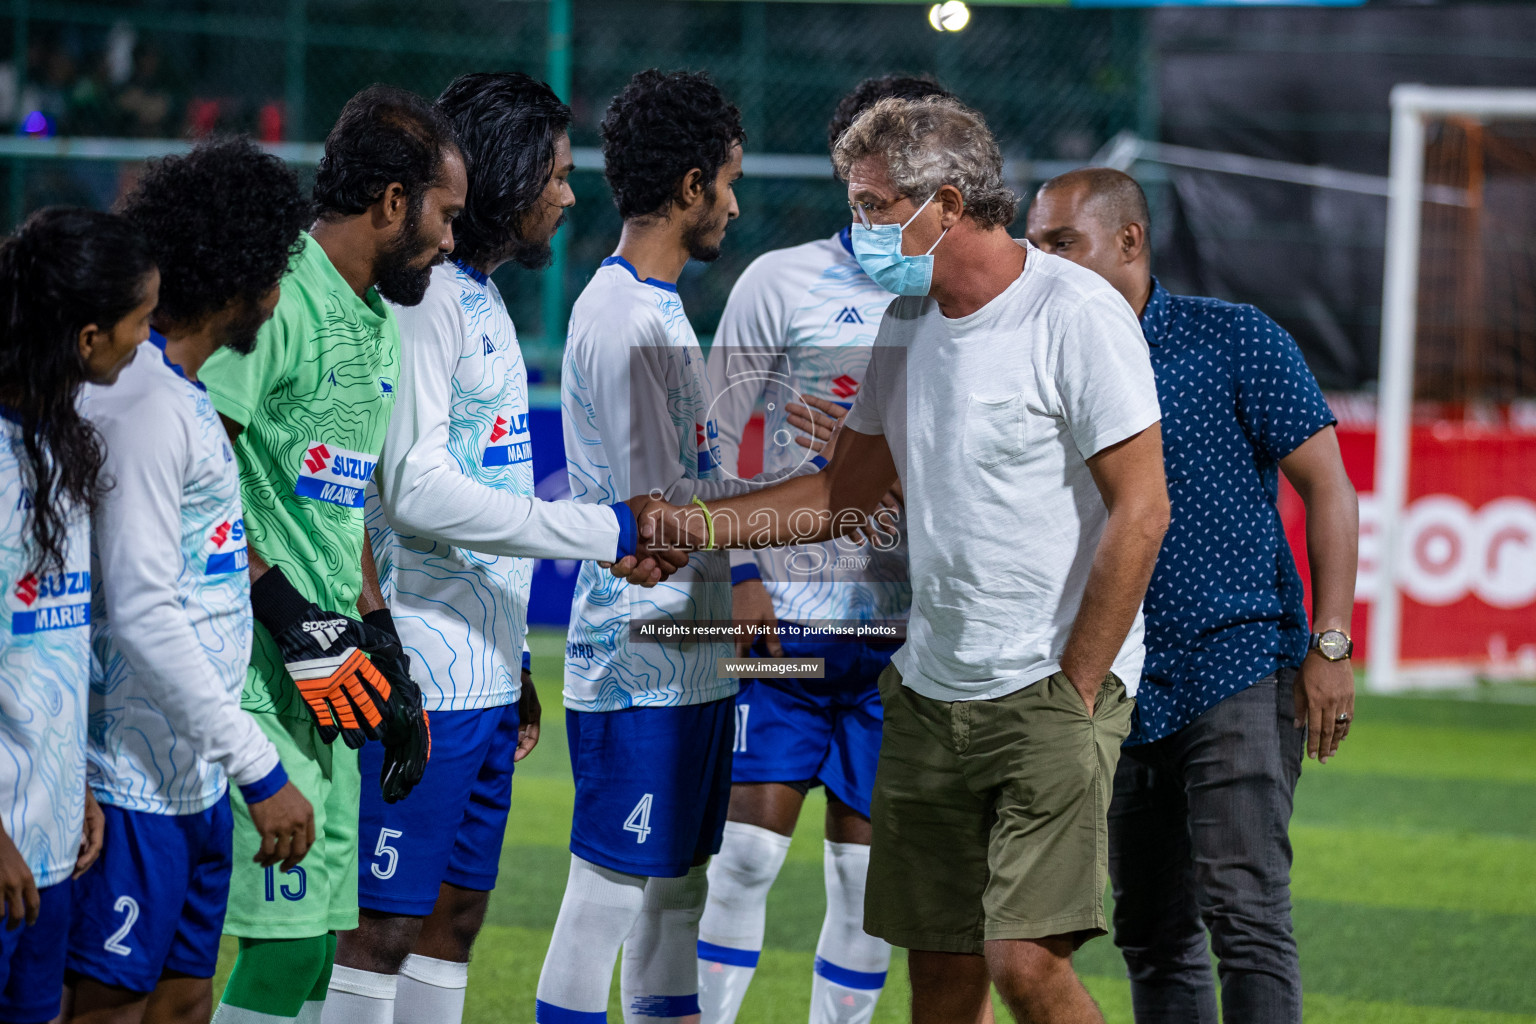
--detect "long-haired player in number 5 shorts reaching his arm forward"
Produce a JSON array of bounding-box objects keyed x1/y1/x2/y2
[{"x1": 324, "y1": 72, "x2": 684, "y2": 1024}]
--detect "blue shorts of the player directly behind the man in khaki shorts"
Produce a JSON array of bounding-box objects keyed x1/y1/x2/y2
[{"x1": 731, "y1": 640, "x2": 895, "y2": 818}]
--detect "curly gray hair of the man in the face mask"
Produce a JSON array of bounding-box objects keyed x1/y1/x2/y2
[{"x1": 833, "y1": 97, "x2": 1018, "y2": 227}]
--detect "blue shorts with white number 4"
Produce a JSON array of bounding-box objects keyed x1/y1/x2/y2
[{"x1": 565, "y1": 697, "x2": 736, "y2": 878}]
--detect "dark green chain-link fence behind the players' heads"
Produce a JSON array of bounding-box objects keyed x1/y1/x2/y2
[{"x1": 0, "y1": 0, "x2": 1155, "y2": 373}]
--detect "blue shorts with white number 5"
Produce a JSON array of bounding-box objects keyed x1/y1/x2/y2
[{"x1": 358, "y1": 705, "x2": 518, "y2": 917}]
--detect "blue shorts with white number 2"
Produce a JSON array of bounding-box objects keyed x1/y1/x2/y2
[{"x1": 69, "y1": 792, "x2": 235, "y2": 992}]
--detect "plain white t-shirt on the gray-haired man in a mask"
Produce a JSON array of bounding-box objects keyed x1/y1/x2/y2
[{"x1": 848, "y1": 246, "x2": 1160, "y2": 700}]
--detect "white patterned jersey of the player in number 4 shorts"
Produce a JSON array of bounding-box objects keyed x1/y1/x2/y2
[{"x1": 561, "y1": 256, "x2": 761, "y2": 711}]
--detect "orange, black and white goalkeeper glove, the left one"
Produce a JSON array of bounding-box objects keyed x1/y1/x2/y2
[{"x1": 250, "y1": 565, "x2": 392, "y2": 749}]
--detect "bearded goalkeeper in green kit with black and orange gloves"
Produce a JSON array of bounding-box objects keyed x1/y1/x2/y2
[{"x1": 200, "y1": 86, "x2": 465, "y2": 1024}]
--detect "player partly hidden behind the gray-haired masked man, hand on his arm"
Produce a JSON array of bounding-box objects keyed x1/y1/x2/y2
[{"x1": 699, "y1": 75, "x2": 949, "y2": 1024}]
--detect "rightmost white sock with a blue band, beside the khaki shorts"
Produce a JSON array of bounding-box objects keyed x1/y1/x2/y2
[{"x1": 811, "y1": 843, "x2": 891, "y2": 1024}]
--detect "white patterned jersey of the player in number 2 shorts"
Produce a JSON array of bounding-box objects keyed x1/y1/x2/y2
[{"x1": 83, "y1": 333, "x2": 278, "y2": 814}]
